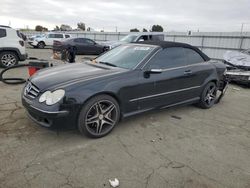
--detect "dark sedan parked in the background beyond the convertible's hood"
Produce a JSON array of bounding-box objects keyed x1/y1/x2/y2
[{"x1": 53, "y1": 38, "x2": 108, "y2": 55}]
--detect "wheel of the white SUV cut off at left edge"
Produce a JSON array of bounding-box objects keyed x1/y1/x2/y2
[{"x1": 0, "y1": 51, "x2": 19, "y2": 68}]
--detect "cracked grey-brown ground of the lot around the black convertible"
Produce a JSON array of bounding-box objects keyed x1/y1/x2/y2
[{"x1": 0, "y1": 49, "x2": 250, "y2": 188}]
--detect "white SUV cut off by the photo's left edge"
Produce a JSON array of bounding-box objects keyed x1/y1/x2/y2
[{"x1": 0, "y1": 25, "x2": 27, "y2": 68}]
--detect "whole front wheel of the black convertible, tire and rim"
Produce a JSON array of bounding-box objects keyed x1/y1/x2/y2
[{"x1": 77, "y1": 95, "x2": 120, "y2": 138}]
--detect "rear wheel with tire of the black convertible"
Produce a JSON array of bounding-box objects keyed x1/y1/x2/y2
[{"x1": 198, "y1": 82, "x2": 218, "y2": 109}]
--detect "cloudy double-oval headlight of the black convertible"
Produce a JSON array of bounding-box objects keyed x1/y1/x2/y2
[{"x1": 39, "y1": 89, "x2": 65, "y2": 105}]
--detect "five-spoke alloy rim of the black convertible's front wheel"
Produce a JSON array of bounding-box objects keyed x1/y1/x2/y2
[{"x1": 85, "y1": 100, "x2": 118, "y2": 136}]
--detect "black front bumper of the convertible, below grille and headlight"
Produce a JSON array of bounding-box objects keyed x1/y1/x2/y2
[{"x1": 22, "y1": 96, "x2": 73, "y2": 127}]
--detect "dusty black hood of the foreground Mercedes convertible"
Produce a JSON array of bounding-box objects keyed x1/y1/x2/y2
[{"x1": 29, "y1": 63, "x2": 124, "y2": 91}]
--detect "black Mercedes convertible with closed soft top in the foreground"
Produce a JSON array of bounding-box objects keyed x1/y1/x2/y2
[{"x1": 22, "y1": 42, "x2": 226, "y2": 137}]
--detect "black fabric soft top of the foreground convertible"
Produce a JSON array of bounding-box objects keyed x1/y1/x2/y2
[{"x1": 136, "y1": 41, "x2": 210, "y2": 61}]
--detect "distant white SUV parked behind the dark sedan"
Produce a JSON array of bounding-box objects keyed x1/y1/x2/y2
[{"x1": 28, "y1": 33, "x2": 71, "y2": 48}]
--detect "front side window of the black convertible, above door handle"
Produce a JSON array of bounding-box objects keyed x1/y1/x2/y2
[{"x1": 148, "y1": 47, "x2": 187, "y2": 69}]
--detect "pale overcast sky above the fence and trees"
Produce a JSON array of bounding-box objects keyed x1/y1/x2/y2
[{"x1": 0, "y1": 0, "x2": 250, "y2": 32}]
